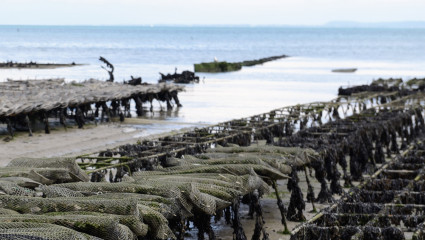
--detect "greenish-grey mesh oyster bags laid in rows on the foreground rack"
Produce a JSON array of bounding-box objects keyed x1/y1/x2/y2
[{"x1": 0, "y1": 143, "x2": 309, "y2": 239}]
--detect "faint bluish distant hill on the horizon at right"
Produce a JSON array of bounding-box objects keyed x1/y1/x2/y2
[{"x1": 324, "y1": 21, "x2": 425, "y2": 28}]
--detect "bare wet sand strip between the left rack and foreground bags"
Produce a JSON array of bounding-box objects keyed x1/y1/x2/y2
[{"x1": 0, "y1": 119, "x2": 202, "y2": 166}]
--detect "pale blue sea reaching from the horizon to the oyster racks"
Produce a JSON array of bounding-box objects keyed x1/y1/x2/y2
[{"x1": 0, "y1": 26, "x2": 425, "y2": 128}]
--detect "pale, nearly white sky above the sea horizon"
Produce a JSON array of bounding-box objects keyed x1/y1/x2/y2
[{"x1": 0, "y1": 0, "x2": 425, "y2": 25}]
